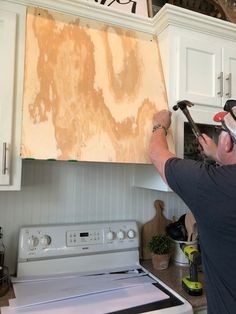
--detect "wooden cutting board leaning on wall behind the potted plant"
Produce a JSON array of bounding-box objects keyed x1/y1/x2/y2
[{"x1": 141, "y1": 200, "x2": 172, "y2": 260}]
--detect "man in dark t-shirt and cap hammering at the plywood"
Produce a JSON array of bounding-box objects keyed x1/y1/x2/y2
[{"x1": 149, "y1": 100, "x2": 236, "y2": 314}]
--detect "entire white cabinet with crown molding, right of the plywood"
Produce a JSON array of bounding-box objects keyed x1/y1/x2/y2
[{"x1": 134, "y1": 4, "x2": 236, "y2": 191}]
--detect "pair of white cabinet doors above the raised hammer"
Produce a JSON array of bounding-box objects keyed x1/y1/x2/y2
[{"x1": 176, "y1": 34, "x2": 236, "y2": 108}]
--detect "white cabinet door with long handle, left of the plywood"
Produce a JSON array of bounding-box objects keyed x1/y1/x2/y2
[{"x1": 0, "y1": 10, "x2": 16, "y2": 185}]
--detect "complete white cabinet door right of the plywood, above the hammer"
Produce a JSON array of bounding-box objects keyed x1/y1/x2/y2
[{"x1": 176, "y1": 38, "x2": 223, "y2": 107}]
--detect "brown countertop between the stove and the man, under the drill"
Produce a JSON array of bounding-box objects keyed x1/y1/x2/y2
[{"x1": 141, "y1": 260, "x2": 207, "y2": 309}]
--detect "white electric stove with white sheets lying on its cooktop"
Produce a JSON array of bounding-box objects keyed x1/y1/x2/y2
[{"x1": 1, "y1": 221, "x2": 193, "y2": 314}]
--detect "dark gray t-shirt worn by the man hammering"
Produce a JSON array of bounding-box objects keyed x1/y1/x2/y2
[{"x1": 165, "y1": 158, "x2": 236, "y2": 314}]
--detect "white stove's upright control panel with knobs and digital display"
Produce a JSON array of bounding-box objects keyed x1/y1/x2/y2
[{"x1": 18, "y1": 221, "x2": 139, "y2": 261}]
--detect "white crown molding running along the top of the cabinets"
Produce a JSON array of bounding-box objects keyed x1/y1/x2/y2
[{"x1": 0, "y1": 0, "x2": 236, "y2": 41}]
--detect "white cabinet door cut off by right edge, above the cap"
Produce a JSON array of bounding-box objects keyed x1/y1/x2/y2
[{"x1": 223, "y1": 48, "x2": 236, "y2": 103}]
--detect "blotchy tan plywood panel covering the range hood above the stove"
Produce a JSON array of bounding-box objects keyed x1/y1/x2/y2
[{"x1": 22, "y1": 8, "x2": 171, "y2": 163}]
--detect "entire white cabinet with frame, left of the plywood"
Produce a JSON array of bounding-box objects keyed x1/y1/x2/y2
[{"x1": 0, "y1": 2, "x2": 25, "y2": 190}]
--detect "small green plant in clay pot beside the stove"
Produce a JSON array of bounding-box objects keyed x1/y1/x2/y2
[{"x1": 148, "y1": 234, "x2": 173, "y2": 270}]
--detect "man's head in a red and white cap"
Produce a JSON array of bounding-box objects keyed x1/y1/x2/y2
[{"x1": 214, "y1": 100, "x2": 236, "y2": 164}]
